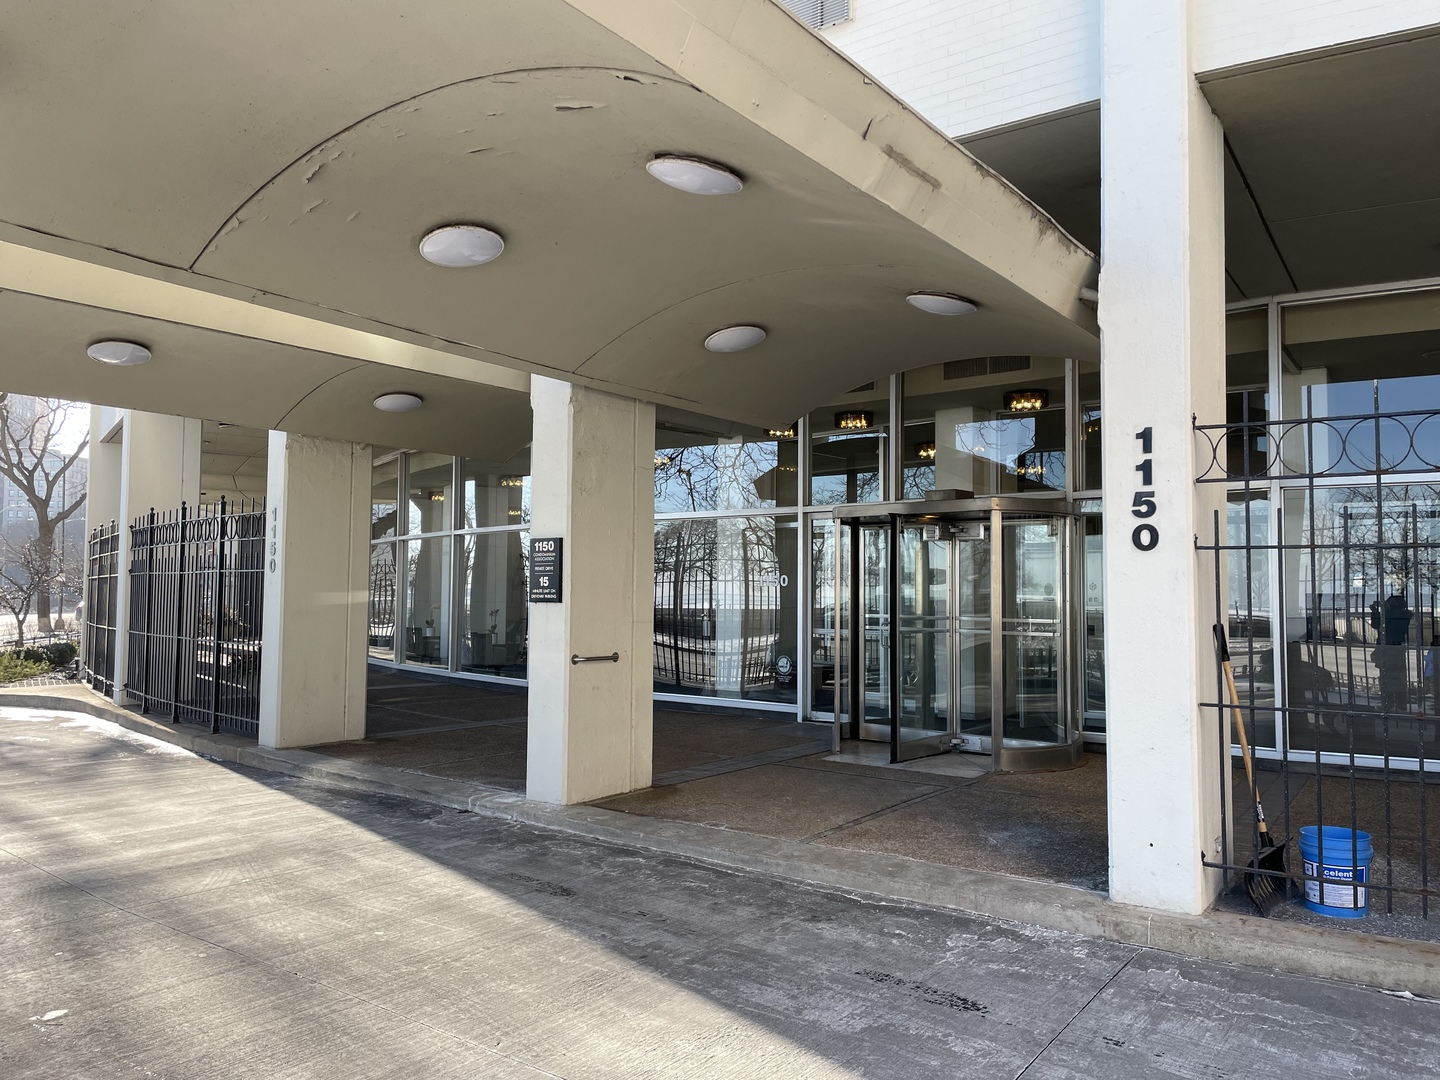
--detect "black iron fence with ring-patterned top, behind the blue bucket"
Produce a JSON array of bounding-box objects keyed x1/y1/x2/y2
[{"x1": 1197, "y1": 400, "x2": 1440, "y2": 919}]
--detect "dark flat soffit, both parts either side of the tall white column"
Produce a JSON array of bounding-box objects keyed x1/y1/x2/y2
[{"x1": 962, "y1": 27, "x2": 1440, "y2": 301}]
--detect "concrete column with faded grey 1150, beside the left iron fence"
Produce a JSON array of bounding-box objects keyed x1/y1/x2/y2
[{"x1": 259, "y1": 431, "x2": 370, "y2": 747}]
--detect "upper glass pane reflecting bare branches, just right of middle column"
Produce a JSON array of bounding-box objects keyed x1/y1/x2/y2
[{"x1": 655, "y1": 442, "x2": 795, "y2": 513}]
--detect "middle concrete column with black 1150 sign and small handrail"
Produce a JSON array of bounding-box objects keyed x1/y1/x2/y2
[{"x1": 526, "y1": 376, "x2": 655, "y2": 802}]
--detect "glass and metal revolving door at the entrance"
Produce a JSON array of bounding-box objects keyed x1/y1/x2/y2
[{"x1": 835, "y1": 498, "x2": 1081, "y2": 772}]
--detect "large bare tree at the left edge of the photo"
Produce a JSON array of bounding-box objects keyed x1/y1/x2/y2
[{"x1": 0, "y1": 393, "x2": 88, "y2": 634}]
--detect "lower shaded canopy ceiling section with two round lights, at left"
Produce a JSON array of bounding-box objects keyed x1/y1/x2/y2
[{"x1": 0, "y1": 291, "x2": 530, "y2": 458}]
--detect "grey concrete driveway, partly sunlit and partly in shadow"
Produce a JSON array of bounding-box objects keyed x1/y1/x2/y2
[{"x1": 8, "y1": 710, "x2": 1440, "y2": 1080}]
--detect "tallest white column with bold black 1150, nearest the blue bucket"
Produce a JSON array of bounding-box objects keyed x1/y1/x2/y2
[{"x1": 1100, "y1": 0, "x2": 1225, "y2": 913}]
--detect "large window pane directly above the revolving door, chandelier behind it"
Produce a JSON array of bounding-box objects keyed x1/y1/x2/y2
[{"x1": 904, "y1": 356, "x2": 1067, "y2": 498}]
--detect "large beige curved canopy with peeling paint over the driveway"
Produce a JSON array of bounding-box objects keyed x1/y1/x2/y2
[{"x1": 0, "y1": 0, "x2": 1099, "y2": 449}]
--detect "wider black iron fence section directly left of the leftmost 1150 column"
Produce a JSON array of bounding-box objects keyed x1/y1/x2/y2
[{"x1": 125, "y1": 500, "x2": 265, "y2": 737}]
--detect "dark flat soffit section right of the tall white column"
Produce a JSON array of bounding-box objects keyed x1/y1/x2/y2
[{"x1": 1201, "y1": 29, "x2": 1440, "y2": 295}]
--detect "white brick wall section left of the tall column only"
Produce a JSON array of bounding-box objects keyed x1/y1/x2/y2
[{"x1": 824, "y1": 0, "x2": 1100, "y2": 135}]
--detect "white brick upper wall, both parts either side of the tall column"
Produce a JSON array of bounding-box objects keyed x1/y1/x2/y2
[{"x1": 824, "y1": 0, "x2": 1440, "y2": 137}]
